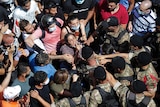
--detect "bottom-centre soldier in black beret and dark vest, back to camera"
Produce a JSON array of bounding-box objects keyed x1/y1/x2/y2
[{"x1": 89, "y1": 66, "x2": 119, "y2": 107}]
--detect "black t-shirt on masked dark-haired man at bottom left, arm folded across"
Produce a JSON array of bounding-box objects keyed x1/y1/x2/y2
[{"x1": 30, "y1": 85, "x2": 51, "y2": 107}]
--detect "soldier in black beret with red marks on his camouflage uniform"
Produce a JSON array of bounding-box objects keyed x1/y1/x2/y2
[{"x1": 137, "y1": 52, "x2": 159, "y2": 97}]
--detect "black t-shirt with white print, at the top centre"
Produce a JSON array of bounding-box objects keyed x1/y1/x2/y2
[{"x1": 62, "y1": 0, "x2": 96, "y2": 19}]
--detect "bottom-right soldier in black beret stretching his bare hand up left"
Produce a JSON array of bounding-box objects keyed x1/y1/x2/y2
[{"x1": 107, "y1": 72, "x2": 156, "y2": 107}]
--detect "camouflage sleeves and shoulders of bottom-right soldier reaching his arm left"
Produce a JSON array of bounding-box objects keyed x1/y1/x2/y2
[{"x1": 113, "y1": 82, "x2": 156, "y2": 107}]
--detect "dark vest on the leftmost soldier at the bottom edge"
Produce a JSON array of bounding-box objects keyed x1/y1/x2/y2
[{"x1": 68, "y1": 95, "x2": 87, "y2": 107}]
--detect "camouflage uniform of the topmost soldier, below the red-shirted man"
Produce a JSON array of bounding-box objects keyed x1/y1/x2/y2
[{"x1": 107, "y1": 26, "x2": 130, "y2": 44}]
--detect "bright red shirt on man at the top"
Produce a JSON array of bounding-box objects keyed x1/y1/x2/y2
[{"x1": 98, "y1": 0, "x2": 129, "y2": 24}]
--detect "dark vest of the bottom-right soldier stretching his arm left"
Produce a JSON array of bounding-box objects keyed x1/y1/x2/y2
[{"x1": 126, "y1": 92, "x2": 151, "y2": 107}]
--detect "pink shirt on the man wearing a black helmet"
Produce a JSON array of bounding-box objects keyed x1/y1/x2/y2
[{"x1": 33, "y1": 18, "x2": 63, "y2": 53}]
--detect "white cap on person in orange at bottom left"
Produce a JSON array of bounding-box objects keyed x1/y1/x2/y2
[{"x1": 3, "y1": 85, "x2": 21, "y2": 100}]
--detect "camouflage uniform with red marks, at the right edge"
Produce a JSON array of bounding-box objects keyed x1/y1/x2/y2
[{"x1": 137, "y1": 63, "x2": 158, "y2": 92}]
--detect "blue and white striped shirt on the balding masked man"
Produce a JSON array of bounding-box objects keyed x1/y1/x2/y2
[{"x1": 132, "y1": 2, "x2": 156, "y2": 36}]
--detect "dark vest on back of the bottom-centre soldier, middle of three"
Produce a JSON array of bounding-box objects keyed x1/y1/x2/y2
[{"x1": 96, "y1": 87, "x2": 119, "y2": 107}]
